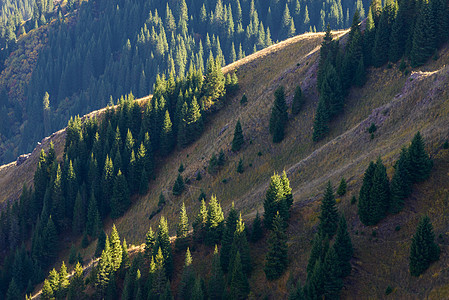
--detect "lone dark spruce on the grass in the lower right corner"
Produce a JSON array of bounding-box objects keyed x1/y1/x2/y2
[{"x1": 409, "y1": 216, "x2": 440, "y2": 276}]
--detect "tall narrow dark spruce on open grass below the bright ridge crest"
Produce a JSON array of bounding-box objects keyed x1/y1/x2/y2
[{"x1": 270, "y1": 86, "x2": 288, "y2": 143}]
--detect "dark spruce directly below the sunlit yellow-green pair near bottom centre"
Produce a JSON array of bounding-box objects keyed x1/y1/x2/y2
[{"x1": 264, "y1": 214, "x2": 288, "y2": 280}]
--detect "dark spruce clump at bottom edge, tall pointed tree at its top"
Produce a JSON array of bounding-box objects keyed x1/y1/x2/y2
[{"x1": 290, "y1": 182, "x2": 354, "y2": 299}]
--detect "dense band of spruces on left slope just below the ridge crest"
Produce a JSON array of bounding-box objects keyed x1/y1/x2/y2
[{"x1": 0, "y1": 65, "x2": 237, "y2": 298}]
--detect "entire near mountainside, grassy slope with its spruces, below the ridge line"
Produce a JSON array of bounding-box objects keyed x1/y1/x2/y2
[{"x1": 0, "y1": 0, "x2": 449, "y2": 299}]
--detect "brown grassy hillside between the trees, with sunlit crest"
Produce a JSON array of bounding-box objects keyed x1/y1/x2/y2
[{"x1": 0, "y1": 27, "x2": 449, "y2": 299}]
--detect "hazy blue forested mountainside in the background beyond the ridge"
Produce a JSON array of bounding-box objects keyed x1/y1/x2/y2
[{"x1": 0, "y1": 0, "x2": 369, "y2": 162}]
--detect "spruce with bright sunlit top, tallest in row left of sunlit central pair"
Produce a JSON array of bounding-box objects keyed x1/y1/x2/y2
[{"x1": 206, "y1": 195, "x2": 224, "y2": 245}]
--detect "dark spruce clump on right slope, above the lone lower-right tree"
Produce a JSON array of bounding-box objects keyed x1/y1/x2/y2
[{"x1": 358, "y1": 132, "x2": 432, "y2": 226}]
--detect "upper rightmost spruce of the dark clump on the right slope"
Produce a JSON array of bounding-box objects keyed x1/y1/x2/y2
[{"x1": 408, "y1": 131, "x2": 432, "y2": 182}]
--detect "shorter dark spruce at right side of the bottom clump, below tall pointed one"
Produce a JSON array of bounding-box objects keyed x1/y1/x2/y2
[{"x1": 332, "y1": 216, "x2": 354, "y2": 278}]
